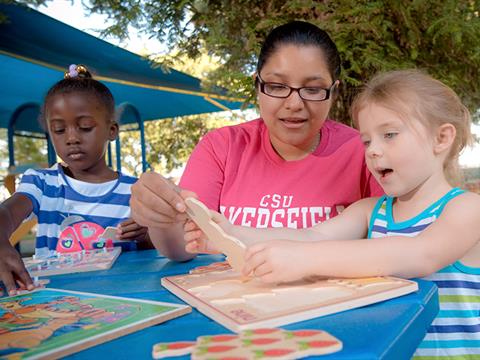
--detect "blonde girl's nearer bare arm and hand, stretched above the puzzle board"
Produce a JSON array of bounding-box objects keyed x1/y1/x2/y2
[{"x1": 244, "y1": 193, "x2": 480, "y2": 282}]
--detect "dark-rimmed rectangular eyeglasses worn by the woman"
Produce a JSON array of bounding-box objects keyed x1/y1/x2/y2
[{"x1": 257, "y1": 74, "x2": 335, "y2": 101}]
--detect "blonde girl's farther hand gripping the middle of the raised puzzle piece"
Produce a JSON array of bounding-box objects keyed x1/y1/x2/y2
[{"x1": 183, "y1": 211, "x2": 233, "y2": 254}]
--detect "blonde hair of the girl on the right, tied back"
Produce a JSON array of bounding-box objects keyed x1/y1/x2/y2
[{"x1": 351, "y1": 70, "x2": 473, "y2": 185}]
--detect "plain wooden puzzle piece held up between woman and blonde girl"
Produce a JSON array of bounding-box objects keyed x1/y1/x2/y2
[{"x1": 185, "y1": 198, "x2": 246, "y2": 272}]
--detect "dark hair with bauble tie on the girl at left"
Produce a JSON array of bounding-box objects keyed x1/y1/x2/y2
[{"x1": 40, "y1": 65, "x2": 115, "y2": 129}]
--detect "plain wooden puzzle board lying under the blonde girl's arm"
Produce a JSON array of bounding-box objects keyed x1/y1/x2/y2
[{"x1": 162, "y1": 269, "x2": 418, "y2": 332}]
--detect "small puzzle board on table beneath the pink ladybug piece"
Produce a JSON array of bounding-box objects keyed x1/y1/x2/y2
[{"x1": 23, "y1": 247, "x2": 122, "y2": 276}]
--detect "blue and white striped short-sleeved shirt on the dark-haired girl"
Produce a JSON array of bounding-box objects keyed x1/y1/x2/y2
[{"x1": 17, "y1": 164, "x2": 137, "y2": 255}]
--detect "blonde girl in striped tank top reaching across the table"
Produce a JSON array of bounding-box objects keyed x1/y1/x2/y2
[{"x1": 185, "y1": 70, "x2": 480, "y2": 359}]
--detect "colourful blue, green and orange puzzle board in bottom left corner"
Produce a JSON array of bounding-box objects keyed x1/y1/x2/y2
[{"x1": 0, "y1": 289, "x2": 191, "y2": 359}]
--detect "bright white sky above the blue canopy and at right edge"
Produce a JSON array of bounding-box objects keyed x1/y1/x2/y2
[{"x1": 37, "y1": 0, "x2": 480, "y2": 167}]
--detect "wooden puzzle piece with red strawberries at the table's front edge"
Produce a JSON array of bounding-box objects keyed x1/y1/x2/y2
[{"x1": 152, "y1": 328, "x2": 342, "y2": 360}]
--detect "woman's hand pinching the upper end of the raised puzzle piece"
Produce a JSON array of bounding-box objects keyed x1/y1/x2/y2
[{"x1": 130, "y1": 171, "x2": 187, "y2": 228}]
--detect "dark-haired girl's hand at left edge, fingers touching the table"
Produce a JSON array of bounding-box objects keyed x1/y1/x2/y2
[{"x1": 0, "y1": 243, "x2": 35, "y2": 296}]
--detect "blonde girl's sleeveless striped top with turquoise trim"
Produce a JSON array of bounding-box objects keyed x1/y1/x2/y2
[{"x1": 368, "y1": 188, "x2": 480, "y2": 360}]
